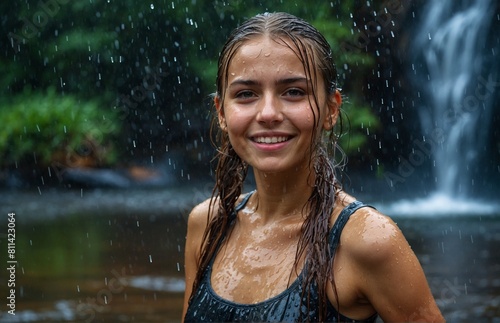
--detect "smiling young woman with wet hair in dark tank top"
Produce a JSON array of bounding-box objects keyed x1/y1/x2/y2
[{"x1": 183, "y1": 13, "x2": 443, "y2": 322}]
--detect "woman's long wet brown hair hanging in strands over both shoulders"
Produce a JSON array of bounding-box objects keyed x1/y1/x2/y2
[{"x1": 193, "y1": 12, "x2": 341, "y2": 321}]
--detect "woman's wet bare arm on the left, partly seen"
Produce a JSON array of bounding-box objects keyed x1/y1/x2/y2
[{"x1": 182, "y1": 200, "x2": 210, "y2": 321}]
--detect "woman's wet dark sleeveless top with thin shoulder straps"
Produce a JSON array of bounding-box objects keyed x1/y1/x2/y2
[{"x1": 184, "y1": 192, "x2": 377, "y2": 322}]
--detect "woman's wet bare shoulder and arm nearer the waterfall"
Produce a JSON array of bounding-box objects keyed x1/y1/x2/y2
[{"x1": 341, "y1": 208, "x2": 444, "y2": 322}]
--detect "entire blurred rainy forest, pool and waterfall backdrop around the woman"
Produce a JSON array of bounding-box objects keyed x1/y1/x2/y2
[{"x1": 0, "y1": 0, "x2": 500, "y2": 322}]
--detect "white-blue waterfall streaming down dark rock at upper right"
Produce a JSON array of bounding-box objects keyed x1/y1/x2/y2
[{"x1": 412, "y1": 0, "x2": 497, "y2": 198}]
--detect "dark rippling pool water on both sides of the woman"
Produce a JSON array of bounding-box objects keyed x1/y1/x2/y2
[{"x1": 0, "y1": 187, "x2": 500, "y2": 322}]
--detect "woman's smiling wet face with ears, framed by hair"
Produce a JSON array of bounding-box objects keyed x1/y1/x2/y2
[{"x1": 215, "y1": 36, "x2": 340, "y2": 173}]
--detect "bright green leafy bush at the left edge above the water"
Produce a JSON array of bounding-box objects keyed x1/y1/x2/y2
[{"x1": 0, "y1": 88, "x2": 119, "y2": 165}]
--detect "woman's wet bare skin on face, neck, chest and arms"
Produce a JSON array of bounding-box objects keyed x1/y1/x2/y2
[{"x1": 184, "y1": 37, "x2": 442, "y2": 321}]
